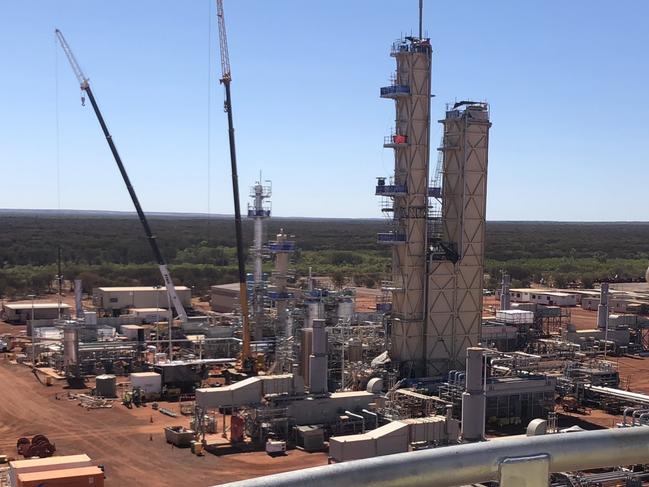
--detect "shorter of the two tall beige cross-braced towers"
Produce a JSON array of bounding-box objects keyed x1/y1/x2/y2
[{"x1": 424, "y1": 102, "x2": 491, "y2": 375}]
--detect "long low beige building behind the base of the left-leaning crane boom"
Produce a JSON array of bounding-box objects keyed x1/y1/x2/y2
[{"x1": 92, "y1": 286, "x2": 192, "y2": 314}]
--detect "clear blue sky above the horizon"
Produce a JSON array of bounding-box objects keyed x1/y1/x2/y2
[{"x1": 0, "y1": 0, "x2": 649, "y2": 220}]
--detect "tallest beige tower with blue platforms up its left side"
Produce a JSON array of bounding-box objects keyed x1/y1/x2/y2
[{"x1": 376, "y1": 37, "x2": 432, "y2": 375}]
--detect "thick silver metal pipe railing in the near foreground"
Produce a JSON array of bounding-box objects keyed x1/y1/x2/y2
[{"x1": 219, "y1": 427, "x2": 649, "y2": 487}]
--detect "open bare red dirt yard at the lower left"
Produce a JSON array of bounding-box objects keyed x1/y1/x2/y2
[{"x1": 0, "y1": 358, "x2": 327, "y2": 487}]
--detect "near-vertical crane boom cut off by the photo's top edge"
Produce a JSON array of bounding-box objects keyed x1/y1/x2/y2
[{"x1": 216, "y1": 0, "x2": 254, "y2": 370}]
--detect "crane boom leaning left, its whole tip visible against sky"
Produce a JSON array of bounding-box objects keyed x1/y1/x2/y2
[{"x1": 54, "y1": 29, "x2": 187, "y2": 323}]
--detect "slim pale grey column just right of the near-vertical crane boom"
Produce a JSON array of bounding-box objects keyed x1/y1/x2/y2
[{"x1": 248, "y1": 177, "x2": 272, "y2": 340}]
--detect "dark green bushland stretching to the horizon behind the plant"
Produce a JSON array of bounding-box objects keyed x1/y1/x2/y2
[{"x1": 0, "y1": 213, "x2": 649, "y2": 297}]
